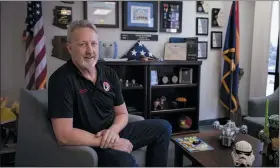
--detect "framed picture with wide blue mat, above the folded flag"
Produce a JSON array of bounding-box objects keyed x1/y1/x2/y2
[{"x1": 122, "y1": 1, "x2": 158, "y2": 32}]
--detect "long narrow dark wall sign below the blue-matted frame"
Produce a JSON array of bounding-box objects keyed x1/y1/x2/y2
[{"x1": 121, "y1": 33, "x2": 158, "y2": 41}]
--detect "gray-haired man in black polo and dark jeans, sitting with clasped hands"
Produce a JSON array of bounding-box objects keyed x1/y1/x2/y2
[{"x1": 48, "y1": 20, "x2": 171, "y2": 167}]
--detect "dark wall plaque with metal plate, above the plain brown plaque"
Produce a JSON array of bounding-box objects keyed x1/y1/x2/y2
[{"x1": 53, "y1": 6, "x2": 72, "y2": 29}]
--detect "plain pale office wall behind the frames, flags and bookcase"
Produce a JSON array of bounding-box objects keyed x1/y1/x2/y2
[{"x1": 1, "y1": 1, "x2": 255, "y2": 120}]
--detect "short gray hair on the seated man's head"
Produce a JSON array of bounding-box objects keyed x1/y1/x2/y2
[{"x1": 67, "y1": 20, "x2": 98, "y2": 42}]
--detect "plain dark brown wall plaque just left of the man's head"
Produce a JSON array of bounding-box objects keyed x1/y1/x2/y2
[{"x1": 52, "y1": 36, "x2": 71, "y2": 61}]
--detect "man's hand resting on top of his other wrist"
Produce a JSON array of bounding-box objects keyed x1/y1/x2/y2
[{"x1": 96, "y1": 129, "x2": 120, "y2": 148}]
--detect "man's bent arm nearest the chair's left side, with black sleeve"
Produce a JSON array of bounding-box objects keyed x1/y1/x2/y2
[{"x1": 48, "y1": 73, "x2": 102, "y2": 146}]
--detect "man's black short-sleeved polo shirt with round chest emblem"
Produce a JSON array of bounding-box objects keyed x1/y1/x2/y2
[{"x1": 48, "y1": 60, "x2": 124, "y2": 134}]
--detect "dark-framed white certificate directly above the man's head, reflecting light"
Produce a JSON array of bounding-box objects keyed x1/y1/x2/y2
[{"x1": 84, "y1": 1, "x2": 119, "y2": 28}]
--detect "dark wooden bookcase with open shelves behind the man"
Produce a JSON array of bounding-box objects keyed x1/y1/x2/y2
[{"x1": 99, "y1": 61, "x2": 202, "y2": 138}]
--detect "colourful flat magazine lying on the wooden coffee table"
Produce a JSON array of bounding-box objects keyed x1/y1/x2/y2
[{"x1": 174, "y1": 136, "x2": 214, "y2": 153}]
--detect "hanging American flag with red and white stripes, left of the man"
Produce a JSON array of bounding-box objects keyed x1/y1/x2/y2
[{"x1": 24, "y1": 1, "x2": 47, "y2": 90}]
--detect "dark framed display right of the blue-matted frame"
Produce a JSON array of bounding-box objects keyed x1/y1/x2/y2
[{"x1": 159, "y1": 1, "x2": 183, "y2": 33}]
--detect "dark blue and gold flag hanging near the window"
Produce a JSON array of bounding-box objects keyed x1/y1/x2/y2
[{"x1": 220, "y1": 1, "x2": 240, "y2": 113}]
